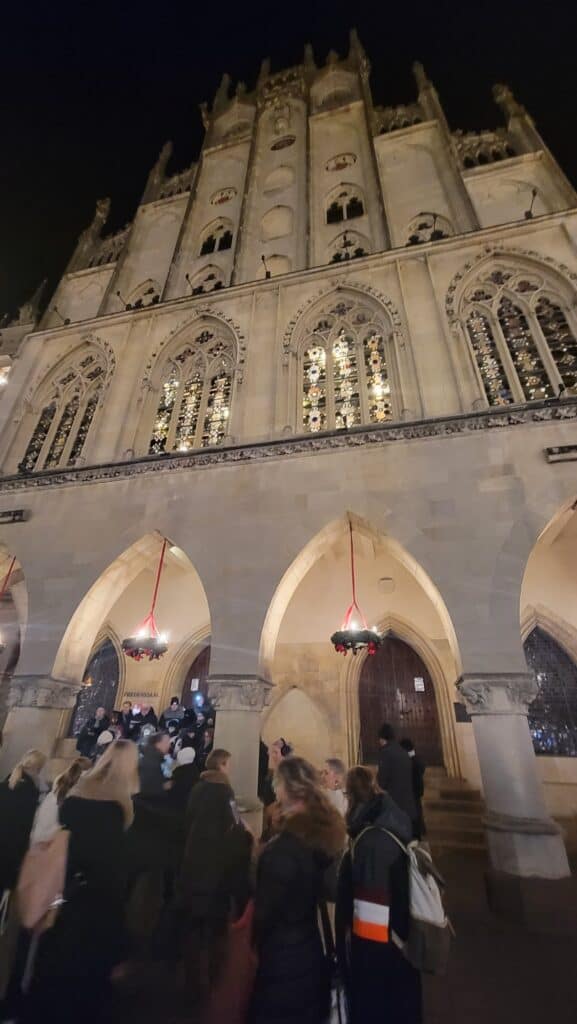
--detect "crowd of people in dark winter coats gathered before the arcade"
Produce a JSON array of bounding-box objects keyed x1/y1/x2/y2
[{"x1": 0, "y1": 720, "x2": 424, "y2": 1024}]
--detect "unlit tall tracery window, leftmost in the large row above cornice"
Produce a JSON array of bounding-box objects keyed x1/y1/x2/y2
[{"x1": 18, "y1": 349, "x2": 106, "y2": 473}]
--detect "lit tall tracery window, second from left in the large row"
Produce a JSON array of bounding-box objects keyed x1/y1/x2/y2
[{"x1": 149, "y1": 323, "x2": 235, "y2": 455}]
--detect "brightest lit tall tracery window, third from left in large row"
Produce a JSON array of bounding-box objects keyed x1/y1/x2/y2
[{"x1": 299, "y1": 297, "x2": 397, "y2": 433}]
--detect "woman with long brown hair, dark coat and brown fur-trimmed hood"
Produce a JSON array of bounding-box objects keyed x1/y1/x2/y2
[{"x1": 249, "y1": 757, "x2": 345, "y2": 1024}]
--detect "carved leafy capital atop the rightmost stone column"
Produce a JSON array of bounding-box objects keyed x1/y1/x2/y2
[{"x1": 457, "y1": 672, "x2": 538, "y2": 715}]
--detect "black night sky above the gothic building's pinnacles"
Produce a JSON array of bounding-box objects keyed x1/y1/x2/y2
[{"x1": 0, "y1": 0, "x2": 577, "y2": 312}]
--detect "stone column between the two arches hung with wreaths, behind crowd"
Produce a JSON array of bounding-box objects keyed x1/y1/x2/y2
[{"x1": 208, "y1": 675, "x2": 272, "y2": 827}]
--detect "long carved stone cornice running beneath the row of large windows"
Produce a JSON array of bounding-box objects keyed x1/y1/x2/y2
[{"x1": 0, "y1": 398, "x2": 577, "y2": 494}]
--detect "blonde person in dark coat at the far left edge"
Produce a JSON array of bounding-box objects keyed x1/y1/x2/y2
[{"x1": 0, "y1": 751, "x2": 46, "y2": 895}]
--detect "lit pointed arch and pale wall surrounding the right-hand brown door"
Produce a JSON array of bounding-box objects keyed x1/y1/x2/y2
[{"x1": 260, "y1": 514, "x2": 460, "y2": 775}]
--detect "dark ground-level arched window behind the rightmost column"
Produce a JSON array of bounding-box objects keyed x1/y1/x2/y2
[{"x1": 524, "y1": 627, "x2": 577, "y2": 758}]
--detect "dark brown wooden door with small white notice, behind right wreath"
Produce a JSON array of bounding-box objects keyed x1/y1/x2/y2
[{"x1": 359, "y1": 636, "x2": 443, "y2": 765}]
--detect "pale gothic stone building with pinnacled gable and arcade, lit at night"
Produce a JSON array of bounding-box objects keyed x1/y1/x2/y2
[{"x1": 0, "y1": 33, "x2": 577, "y2": 913}]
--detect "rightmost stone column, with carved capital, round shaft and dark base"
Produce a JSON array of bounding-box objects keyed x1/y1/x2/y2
[{"x1": 457, "y1": 672, "x2": 573, "y2": 926}]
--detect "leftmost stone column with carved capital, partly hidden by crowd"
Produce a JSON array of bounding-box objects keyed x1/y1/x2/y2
[{"x1": 0, "y1": 676, "x2": 79, "y2": 775}]
